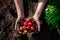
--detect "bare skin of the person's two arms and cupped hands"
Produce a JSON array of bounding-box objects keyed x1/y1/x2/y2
[{"x1": 14, "y1": 0, "x2": 47, "y2": 31}]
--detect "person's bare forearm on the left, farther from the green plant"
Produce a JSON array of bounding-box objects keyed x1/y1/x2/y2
[{"x1": 14, "y1": 0, "x2": 24, "y2": 17}]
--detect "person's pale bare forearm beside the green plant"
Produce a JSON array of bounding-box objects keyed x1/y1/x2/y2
[{"x1": 34, "y1": 0, "x2": 47, "y2": 19}]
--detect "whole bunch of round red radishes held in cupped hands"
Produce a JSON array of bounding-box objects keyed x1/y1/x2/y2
[{"x1": 19, "y1": 18, "x2": 36, "y2": 34}]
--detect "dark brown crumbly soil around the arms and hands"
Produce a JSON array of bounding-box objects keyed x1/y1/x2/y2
[{"x1": 0, "y1": 0, "x2": 60, "y2": 40}]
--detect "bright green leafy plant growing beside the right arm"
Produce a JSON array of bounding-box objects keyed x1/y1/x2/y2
[{"x1": 44, "y1": 0, "x2": 60, "y2": 30}]
